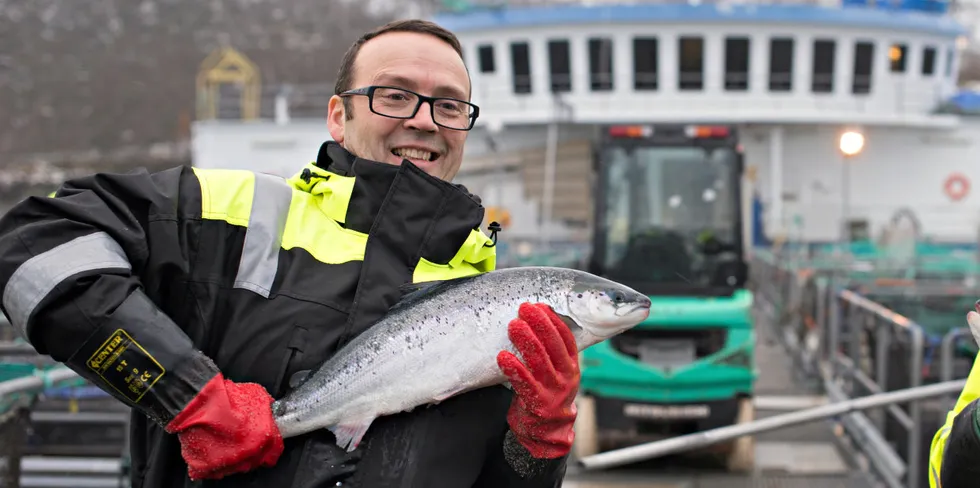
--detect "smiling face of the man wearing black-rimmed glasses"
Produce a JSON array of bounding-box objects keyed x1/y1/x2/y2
[{"x1": 327, "y1": 32, "x2": 470, "y2": 181}]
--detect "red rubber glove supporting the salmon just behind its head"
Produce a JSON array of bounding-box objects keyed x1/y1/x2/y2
[{"x1": 497, "y1": 303, "x2": 580, "y2": 459}]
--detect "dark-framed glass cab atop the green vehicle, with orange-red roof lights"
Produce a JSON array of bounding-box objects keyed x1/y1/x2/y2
[{"x1": 589, "y1": 126, "x2": 747, "y2": 296}]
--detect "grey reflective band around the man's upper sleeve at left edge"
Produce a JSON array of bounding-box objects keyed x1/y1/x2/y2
[{"x1": 3, "y1": 232, "x2": 132, "y2": 337}]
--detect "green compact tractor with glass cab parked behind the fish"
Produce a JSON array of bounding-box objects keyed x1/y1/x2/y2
[{"x1": 575, "y1": 125, "x2": 757, "y2": 472}]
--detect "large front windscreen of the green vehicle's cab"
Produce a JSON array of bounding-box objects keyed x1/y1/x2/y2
[{"x1": 602, "y1": 146, "x2": 739, "y2": 290}]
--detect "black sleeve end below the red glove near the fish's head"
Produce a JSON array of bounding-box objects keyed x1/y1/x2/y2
[{"x1": 473, "y1": 430, "x2": 568, "y2": 488}]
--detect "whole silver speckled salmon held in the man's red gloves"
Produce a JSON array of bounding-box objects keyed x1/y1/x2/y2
[{"x1": 272, "y1": 267, "x2": 650, "y2": 451}]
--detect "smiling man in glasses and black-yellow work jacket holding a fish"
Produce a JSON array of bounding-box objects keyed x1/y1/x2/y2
[{"x1": 0, "y1": 21, "x2": 579, "y2": 488}]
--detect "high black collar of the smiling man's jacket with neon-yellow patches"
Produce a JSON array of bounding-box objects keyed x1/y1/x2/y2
[{"x1": 289, "y1": 141, "x2": 490, "y2": 264}]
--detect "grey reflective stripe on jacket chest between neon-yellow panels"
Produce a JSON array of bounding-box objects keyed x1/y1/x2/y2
[{"x1": 235, "y1": 173, "x2": 293, "y2": 298}]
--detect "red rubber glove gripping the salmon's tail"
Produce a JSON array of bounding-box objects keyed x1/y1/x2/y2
[{"x1": 166, "y1": 373, "x2": 283, "y2": 481}]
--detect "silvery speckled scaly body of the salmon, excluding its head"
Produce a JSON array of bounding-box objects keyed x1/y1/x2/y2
[{"x1": 275, "y1": 267, "x2": 579, "y2": 437}]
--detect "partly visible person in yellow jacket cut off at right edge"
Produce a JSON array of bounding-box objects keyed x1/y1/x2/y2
[{"x1": 929, "y1": 301, "x2": 980, "y2": 488}]
